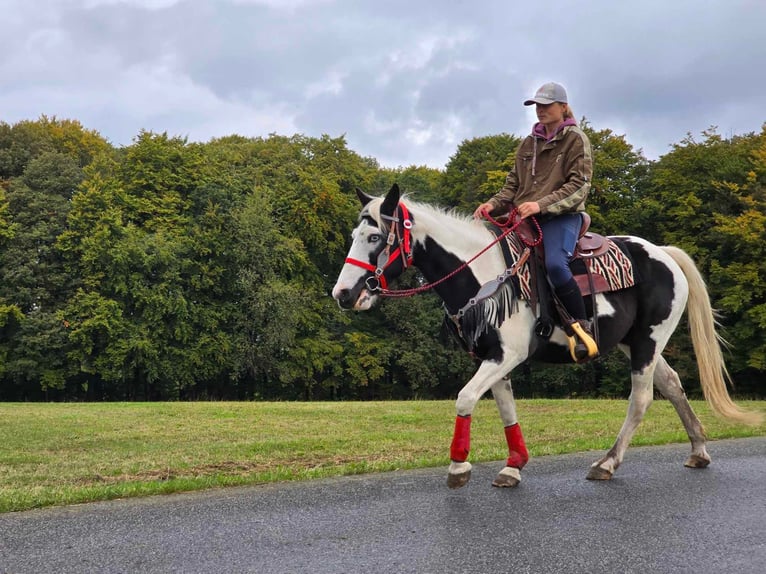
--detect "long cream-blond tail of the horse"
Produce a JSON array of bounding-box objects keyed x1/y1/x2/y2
[{"x1": 662, "y1": 247, "x2": 763, "y2": 425}]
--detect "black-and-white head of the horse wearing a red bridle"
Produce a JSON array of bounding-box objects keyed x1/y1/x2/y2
[{"x1": 332, "y1": 184, "x2": 412, "y2": 311}]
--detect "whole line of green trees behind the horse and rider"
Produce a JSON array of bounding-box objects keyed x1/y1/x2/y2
[{"x1": 0, "y1": 116, "x2": 766, "y2": 401}]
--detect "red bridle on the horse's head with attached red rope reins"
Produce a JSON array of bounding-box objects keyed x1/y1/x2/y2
[{"x1": 346, "y1": 202, "x2": 543, "y2": 297}]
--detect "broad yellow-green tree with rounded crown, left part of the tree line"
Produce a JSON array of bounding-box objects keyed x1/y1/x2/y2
[{"x1": 61, "y1": 132, "x2": 236, "y2": 399}]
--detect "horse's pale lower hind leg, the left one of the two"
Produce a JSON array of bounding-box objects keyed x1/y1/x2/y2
[{"x1": 587, "y1": 363, "x2": 654, "y2": 480}]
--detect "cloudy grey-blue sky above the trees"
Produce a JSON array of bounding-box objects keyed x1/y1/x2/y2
[{"x1": 0, "y1": 0, "x2": 766, "y2": 168}]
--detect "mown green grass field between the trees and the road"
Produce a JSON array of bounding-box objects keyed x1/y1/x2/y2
[{"x1": 0, "y1": 400, "x2": 766, "y2": 512}]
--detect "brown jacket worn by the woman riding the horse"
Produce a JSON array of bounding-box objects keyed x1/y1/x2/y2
[{"x1": 489, "y1": 120, "x2": 593, "y2": 215}]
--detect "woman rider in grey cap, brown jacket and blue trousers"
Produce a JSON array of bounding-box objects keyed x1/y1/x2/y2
[{"x1": 474, "y1": 82, "x2": 598, "y2": 361}]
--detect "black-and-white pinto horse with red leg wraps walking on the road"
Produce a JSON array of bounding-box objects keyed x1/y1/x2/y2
[{"x1": 332, "y1": 184, "x2": 761, "y2": 488}]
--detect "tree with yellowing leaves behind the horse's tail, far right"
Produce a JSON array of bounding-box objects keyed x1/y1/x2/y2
[{"x1": 635, "y1": 128, "x2": 763, "y2": 396}]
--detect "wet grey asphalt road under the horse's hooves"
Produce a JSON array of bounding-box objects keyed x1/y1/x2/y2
[{"x1": 0, "y1": 438, "x2": 766, "y2": 574}]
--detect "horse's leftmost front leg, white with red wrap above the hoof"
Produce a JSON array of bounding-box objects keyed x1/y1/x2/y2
[{"x1": 447, "y1": 361, "x2": 520, "y2": 488}]
